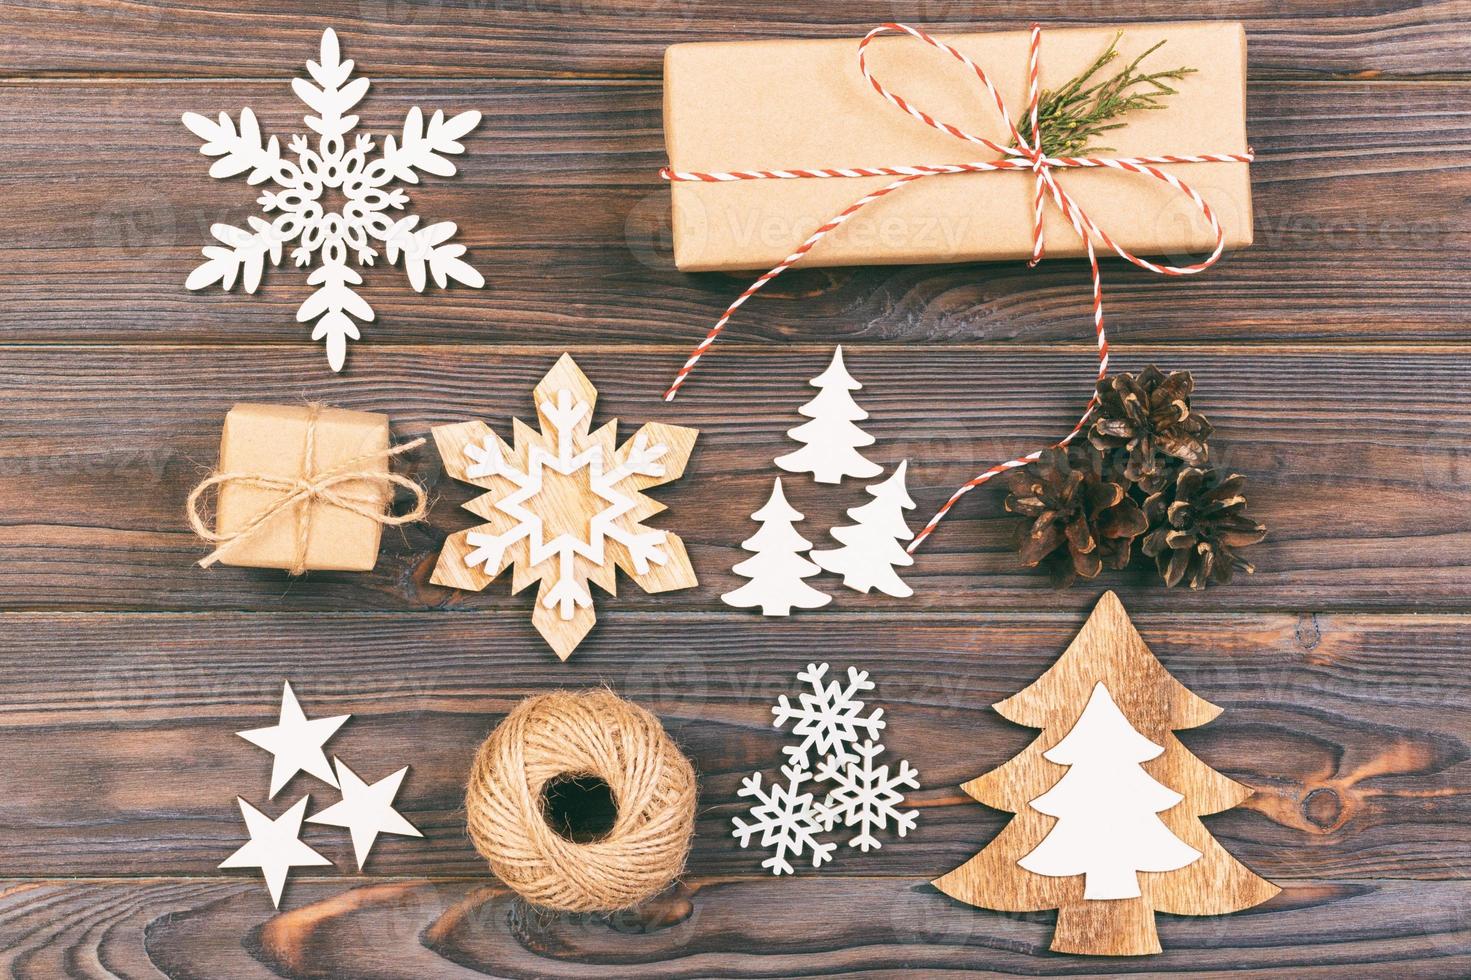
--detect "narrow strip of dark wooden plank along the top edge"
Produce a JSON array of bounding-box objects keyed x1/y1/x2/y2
[{"x1": 0, "y1": 0, "x2": 1471, "y2": 78}]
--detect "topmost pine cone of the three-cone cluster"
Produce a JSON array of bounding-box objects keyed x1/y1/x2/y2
[{"x1": 1089, "y1": 365, "x2": 1211, "y2": 493}]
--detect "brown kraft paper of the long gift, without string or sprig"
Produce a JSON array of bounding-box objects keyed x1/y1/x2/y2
[{"x1": 663, "y1": 22, "x2": 1252, "y2": 272}]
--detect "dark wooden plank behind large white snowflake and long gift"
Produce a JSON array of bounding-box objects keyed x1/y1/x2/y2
[{"x1": 0, "y1": 77, "x2": 1471, "y2": 347}]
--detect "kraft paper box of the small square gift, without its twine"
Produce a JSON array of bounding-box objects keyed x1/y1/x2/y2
[{"x1": 215, "y1": 405, "x2": 388, "y2": 571}]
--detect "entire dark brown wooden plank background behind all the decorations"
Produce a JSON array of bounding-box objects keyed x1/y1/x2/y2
[{"x1": 0, "y1": 0, "x2": 1471, "y2": 979}]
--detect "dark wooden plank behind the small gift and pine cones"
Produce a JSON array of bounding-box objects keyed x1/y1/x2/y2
[{"x1": 0, "y1": 344, "x2": 1471, "y2": 612}]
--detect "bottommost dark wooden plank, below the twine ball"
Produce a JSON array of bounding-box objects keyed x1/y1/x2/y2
[{"x1": 0, "y1": 876, "x2": 1471, "y2": 980}]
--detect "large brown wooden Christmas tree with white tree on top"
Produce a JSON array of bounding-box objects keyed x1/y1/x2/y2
[{"x1": 934, "y1": 592, "x2": 1280, "y2": 956}]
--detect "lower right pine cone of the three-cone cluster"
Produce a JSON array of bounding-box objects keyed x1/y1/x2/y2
[{"x1": 1140, "y1": 466, "x2": 1267, "y2": 589}]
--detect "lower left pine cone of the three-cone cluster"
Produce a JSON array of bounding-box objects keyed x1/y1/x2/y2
[{"x1": 1006, "y1": 441, "x2": 1147, "y2": 589}]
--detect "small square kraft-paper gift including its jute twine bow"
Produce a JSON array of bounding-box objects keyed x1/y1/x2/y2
[{"x1": 188, "y1": 405, "x2": 427, "y2": 575}]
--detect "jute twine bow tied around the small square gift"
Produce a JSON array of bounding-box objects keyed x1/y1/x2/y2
[{"x1": 185, "y1": 402, "x2": 430, "y2": 575}]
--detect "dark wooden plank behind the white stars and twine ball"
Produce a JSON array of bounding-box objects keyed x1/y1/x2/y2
[{"x1": 0, "y1": 606, "x2": 1471, "y2": 882}]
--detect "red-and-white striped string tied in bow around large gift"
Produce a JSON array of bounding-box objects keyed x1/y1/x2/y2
[{"x1": 659, "y1": 24, "x2": 1255, "y2": 553}]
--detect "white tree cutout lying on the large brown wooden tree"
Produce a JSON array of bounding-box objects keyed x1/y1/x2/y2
[{"x1": 1016, "y1": 681, "x2": 1200, "y2": 899}]
